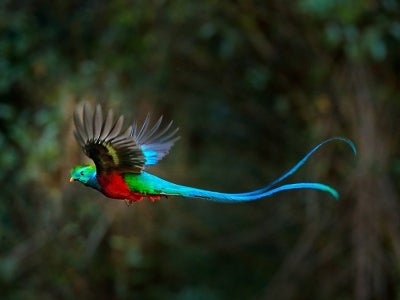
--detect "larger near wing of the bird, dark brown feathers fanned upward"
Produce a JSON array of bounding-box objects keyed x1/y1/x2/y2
[{"x1": 74, "y1": 104, "x2": 146, "y2": 174}]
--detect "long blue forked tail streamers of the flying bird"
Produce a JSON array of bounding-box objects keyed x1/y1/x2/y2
[{"x1": 150, "y1": 137, "x2": 357, "y2": 202}]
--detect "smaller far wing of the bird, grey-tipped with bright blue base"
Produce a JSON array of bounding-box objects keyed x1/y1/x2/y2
[{"x1": 131, "y1": 115, "x2": 179, "y2": 166}]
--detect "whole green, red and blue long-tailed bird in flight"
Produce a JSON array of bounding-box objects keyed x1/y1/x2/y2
[{"x1": 70, "y1": 103, "x2": 357, "y2": 204}]
